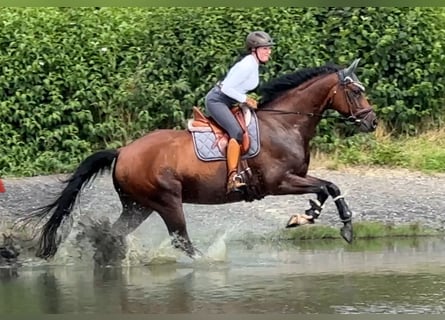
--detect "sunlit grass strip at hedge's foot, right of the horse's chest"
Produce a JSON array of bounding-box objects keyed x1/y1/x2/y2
[{"x1": 311, "y1": 126, "x2": 445, "y2": 173}]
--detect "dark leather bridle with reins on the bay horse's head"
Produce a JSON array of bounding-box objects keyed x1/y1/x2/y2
[{"x1": 255, "y1": 70, "x2": 372, "y2": 125}]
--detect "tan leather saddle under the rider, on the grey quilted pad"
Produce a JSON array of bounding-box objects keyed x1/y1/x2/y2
[{"x1": 187, "y1": 106, "x2": 251, "y2": 155}]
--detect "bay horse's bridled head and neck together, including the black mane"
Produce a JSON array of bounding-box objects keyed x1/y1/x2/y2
[{"x1": 258, "y1": 59, "x2": 377, "y2": 132}]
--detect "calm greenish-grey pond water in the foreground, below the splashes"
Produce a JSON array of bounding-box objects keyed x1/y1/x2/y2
[{"x1": 0, "y1": 239, "x2": 445, "y2": 313}]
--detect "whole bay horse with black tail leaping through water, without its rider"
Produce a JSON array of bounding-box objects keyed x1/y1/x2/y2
[{"x1": 26, "y1": 59, "x2": 377, "y2": 259}]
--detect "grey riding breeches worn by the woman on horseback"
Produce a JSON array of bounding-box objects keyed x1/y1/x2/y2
[{"x1": 205, "y1": 86, "x2": 243, "y2": 143}]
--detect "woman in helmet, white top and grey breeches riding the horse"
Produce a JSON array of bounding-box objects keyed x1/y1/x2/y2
[{"x1": 205, "y1": 31, "x2": 274, "y2": 193}]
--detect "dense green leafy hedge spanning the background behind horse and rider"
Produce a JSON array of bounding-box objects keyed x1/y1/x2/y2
[{"x1": 0, "y1": 7, "x2": 445, "y2": 175}]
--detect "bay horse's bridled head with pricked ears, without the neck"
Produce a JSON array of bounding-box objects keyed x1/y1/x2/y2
[{"x1": 328, "y1": 59, "x2": 377, "y2": 132}]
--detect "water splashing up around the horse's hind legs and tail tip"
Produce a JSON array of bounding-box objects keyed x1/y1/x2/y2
[{"x1": 2, "y1": 212, "x2": 243, "y2": 267}]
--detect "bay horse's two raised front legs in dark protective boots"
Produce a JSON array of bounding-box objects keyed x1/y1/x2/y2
[{"x1": 281, "y1": 174, "x2": 353, "y2": 242}]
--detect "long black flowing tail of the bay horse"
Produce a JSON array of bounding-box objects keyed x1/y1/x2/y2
[{"x1": 27, "y1": 150, "x2": 118, "y2": 259}]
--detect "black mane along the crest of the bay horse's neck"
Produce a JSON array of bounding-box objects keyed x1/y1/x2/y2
[{"x1": 258, "y1": 63, "x2": 342, "y2": 108}]
